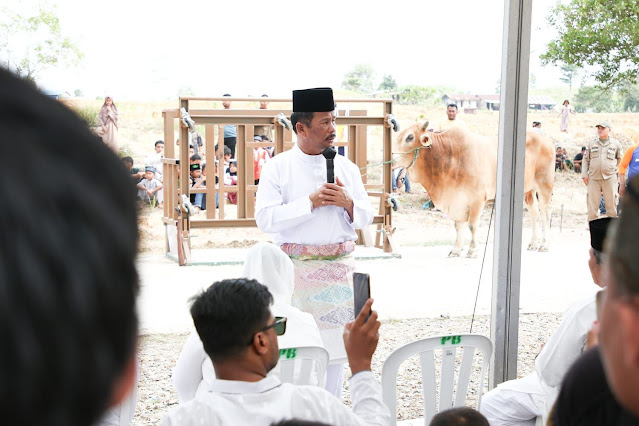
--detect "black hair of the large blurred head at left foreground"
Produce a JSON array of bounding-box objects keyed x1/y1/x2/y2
[{"x1": 0, "y1": 70, "x2": 138, "y2": 426}]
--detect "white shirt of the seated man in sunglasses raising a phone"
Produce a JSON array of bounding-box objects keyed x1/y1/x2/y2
[{"x1": 160, "y1": 371, "x2": 390, "y2": 426}]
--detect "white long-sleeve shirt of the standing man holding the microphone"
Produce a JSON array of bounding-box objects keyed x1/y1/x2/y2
[{"x1": 255, "y1": 145, "x2": 373, "y2": 245}]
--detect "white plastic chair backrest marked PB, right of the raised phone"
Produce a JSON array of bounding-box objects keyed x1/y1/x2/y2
[{"x1": 382, "y1": 334, "x2": 493, "y2": 426}]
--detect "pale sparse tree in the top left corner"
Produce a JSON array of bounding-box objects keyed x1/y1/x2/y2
[{"x1": 0, "y1": 6, "x2": 83, "y2": 83}]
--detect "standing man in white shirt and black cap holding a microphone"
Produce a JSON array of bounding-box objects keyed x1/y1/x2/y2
[{"x1": 255, "y1": 88, "x2": 373, "y2": 397}]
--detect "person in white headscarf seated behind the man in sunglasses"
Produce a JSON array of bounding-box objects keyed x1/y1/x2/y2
[{"x1": 173, "y1": 243, "x2": 323, "y2": 403}]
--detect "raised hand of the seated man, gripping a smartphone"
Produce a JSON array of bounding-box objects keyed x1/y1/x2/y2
[{"x1": 343, "y1": 299, "x2": 382, "y2": 374}]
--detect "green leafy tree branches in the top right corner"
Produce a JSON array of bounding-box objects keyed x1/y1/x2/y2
[{"x1": 541, "y1": 0, "x2": 639, "y2": 88}]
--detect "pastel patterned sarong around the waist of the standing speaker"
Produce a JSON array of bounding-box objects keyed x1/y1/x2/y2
[{"x1": 281, "y1": 241, "x2": 355, "y2": 361}]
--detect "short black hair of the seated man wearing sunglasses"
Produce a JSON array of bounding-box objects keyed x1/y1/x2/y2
[{"x1": 191, "y1": 278, "x2": 273, "y2": 361}]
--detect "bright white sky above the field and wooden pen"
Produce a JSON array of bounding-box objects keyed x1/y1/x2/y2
[{"x1": 22, "y1": 0, "x2": 561, "y2": 99}]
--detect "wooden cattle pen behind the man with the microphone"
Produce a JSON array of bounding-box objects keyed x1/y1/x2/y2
[{"x1": 162, "y1": 97, "x2": 398, "y2": 265}]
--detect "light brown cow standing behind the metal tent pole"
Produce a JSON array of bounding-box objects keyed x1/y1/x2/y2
[{"x1": 393, "y1": 122, "x2": 555, "y2": 257}]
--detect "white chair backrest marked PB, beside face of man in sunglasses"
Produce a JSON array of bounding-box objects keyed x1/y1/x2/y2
[{"x1": 278, "y1": 346, "x2": 328, "y2": 388}]
